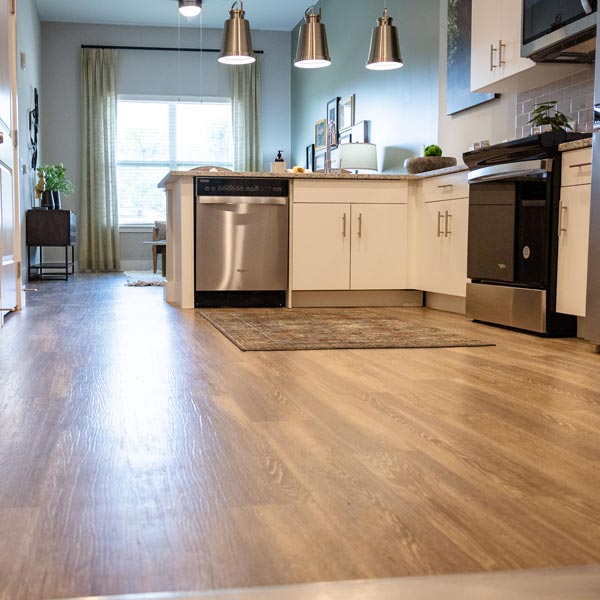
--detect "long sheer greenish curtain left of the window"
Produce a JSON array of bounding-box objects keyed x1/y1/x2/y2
[{"x1": 79, "y1": 48, "x2": 120, "y2": 271}]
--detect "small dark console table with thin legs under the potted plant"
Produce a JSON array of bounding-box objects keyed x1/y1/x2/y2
[{"x1": 25, "y1": 210, "x2": 77, "y2": 280}]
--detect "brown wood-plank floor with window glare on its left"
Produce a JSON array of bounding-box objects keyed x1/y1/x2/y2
[{"x1": 0, "y1": 275, "x2": 600, "y2": 600}]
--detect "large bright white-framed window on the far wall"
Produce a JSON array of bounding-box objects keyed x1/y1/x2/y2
[{"x1": 117, "y1": 99, "x2": 233, "y2": 225}]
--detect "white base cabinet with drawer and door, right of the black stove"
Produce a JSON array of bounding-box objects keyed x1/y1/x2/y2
[{"x1": 556, "y1": 148, "x2": 591, "y2": 317}]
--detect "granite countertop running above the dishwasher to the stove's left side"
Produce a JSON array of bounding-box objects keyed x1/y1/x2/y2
[{"x1": 158, "y1": 165, "x2": 468, "y2": 187}]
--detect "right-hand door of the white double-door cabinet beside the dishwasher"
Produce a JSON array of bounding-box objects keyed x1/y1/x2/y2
[{"x1": 350, "y1": 204, "x2": 407, "y2": 290}]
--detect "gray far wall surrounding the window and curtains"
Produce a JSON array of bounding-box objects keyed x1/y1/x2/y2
[{"x1": 41, "y1": 22, "x2": 291, "y2": 268}]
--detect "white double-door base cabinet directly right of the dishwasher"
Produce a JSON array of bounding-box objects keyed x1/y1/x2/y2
[{"x1": 291, "y1": 180, "x2": 407, "y2": 291}]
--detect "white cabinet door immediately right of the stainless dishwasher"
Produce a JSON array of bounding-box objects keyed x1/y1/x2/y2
[{"x1": 292, "y1": 203, "x2": 350, "y2": 290}]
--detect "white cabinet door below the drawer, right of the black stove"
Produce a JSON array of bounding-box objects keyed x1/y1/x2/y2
[{"x1": 556, "y1": 185, "x2": 591, "y2": 317}]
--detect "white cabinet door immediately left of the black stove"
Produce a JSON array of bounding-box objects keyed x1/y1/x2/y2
[{"x1": 436, "y1": 198, "x2": 469, "y2": 298}]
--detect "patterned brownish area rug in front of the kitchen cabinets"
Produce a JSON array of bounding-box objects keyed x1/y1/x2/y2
[{"x1": 199, "y1": 308, "x2": 493, "y2": 351}]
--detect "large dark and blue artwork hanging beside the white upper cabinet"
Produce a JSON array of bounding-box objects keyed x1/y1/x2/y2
[{"x1": 446, "y1": 0, "x2": 497, "y2": 115}]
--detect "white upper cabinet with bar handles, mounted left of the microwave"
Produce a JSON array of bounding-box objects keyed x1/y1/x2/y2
[{"x1": 471, "y1": 0, "x2": 585, "y2": 93}]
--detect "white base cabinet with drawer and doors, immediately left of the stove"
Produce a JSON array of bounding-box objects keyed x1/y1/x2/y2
[{"x1": 415, "y1": 173, "x2": 469, "y2": 297}]
